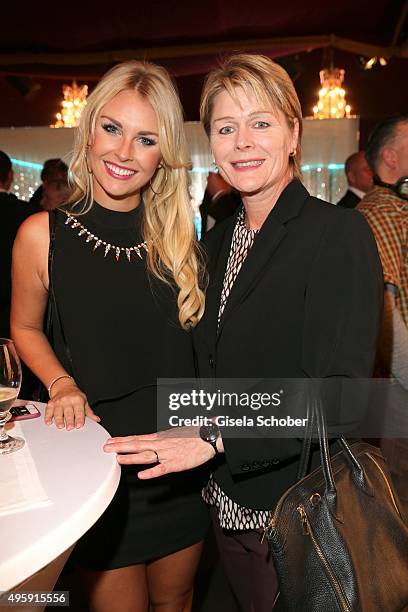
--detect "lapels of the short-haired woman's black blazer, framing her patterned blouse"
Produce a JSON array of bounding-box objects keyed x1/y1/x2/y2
[{"x1": 215, "y1": 179, "x2": 309, "y2": 336}]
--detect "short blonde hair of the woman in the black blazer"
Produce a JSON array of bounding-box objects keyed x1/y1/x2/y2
[{"x1": 200, "y1": 53, "x2": 302, "y2": 178}]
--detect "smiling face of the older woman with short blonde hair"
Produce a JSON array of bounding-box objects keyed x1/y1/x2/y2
[{"x1": 210, "y1": 87, "x2": 298, "y2": 196}]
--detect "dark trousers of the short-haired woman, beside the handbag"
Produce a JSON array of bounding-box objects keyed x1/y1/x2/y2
[{"x1": 211, "y1": 508, "x2": 278, "y2": 612}]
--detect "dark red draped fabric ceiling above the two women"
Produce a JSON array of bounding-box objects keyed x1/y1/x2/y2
[{"x1": 0, "y1": 0, "x2": 408, "y2": 133}]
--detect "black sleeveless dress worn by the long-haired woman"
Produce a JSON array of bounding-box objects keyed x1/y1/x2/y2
[{"x1": 52, "y1": 203, "x2": 208, "y2": 570}]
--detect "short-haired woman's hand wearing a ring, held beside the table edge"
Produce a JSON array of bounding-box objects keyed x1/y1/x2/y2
[{"x1": 103, "y1": 427, "x2": 222, "y2": 480}]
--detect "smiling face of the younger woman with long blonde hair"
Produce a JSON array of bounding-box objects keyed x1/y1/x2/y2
[{"x1": 87, "y1": 90, "x2": 161, "y2": 211}]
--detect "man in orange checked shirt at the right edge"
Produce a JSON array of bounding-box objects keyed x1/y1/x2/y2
[{"x1": 358, "y1": 115, "x2": 408, "y2": 516}]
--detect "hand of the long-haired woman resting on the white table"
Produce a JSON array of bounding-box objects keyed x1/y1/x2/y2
[{"x1": 44, "y1": 378, "x2": 101, "y2": 431}]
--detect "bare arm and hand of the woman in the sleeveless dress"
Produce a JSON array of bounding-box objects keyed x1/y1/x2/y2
[{"x1": 11, "y1": 212, "x2": 99, "y2": 429}]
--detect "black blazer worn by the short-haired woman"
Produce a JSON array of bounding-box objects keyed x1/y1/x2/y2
[{"x1": 193, "y1": 179, "x2": 383, "y2": 509}]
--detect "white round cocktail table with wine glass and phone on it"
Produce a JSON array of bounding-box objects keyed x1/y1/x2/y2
[{"x1": 0, "y1": 402, "x2": 120, "y2": 591}]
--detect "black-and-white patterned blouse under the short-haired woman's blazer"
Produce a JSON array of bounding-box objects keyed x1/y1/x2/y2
[{"x1": 203, "y1": 208, "x2": 272, "y2": 531}]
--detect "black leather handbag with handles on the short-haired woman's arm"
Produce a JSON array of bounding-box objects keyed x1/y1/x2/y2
[{"x1": 266, "y1": 402, "x2": 408, "y2": 612}]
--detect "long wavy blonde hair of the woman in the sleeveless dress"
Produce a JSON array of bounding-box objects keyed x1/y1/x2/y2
[{"x1": 68, "y1": 61, "x2": 205, "y2": 329}]
